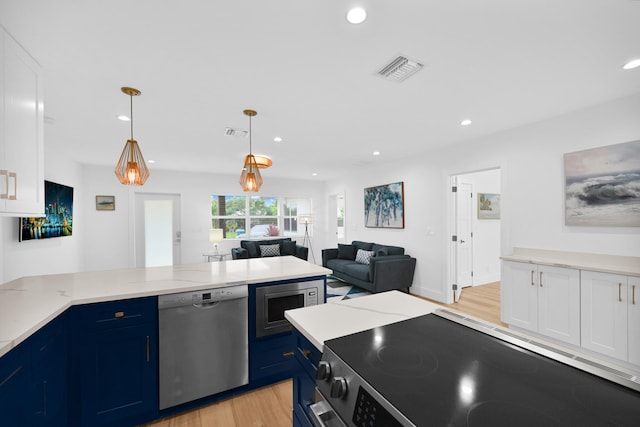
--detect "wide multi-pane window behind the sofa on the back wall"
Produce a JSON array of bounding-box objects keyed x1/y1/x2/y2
[{"x1": 211, "y1": 194, "x2": 311, "y2": 239}]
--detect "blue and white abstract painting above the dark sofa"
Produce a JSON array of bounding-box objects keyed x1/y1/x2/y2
[{"x1": 364, "y1": 182, "x2": 404, "y2": 228}]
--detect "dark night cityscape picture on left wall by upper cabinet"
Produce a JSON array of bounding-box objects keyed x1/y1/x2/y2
[{"x1": 19, "y1": 181, "x2": 73, "y2": 241}]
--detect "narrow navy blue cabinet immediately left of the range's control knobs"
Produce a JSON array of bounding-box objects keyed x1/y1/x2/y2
[{"x1": 293, "y1": 330, "x2": 322, "y2": 427}]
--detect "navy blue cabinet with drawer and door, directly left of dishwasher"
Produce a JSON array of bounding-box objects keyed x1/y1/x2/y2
[{"x1": 70, "y1": 297, "x2": 158, "y2": 426}]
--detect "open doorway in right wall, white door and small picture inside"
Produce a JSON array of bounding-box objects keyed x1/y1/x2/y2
[{"x1": 449, "y1": 168, "x2": 500, "y2": 302}]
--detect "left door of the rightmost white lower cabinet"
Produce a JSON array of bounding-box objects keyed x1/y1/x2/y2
[{"x1": 581, "y1": 271, "x2": 637, "y2": 360}]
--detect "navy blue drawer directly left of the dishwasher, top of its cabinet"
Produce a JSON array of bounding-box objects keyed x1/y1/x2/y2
[{"x1": 71, "y1": 297, "x2": 158, "y2": 332}]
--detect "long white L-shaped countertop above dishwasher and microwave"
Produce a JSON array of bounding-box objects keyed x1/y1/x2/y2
[{"x1": 0, "y1": 256, "x2": 331, "y2": 357}]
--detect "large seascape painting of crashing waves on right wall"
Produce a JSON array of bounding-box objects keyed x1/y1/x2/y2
[{"x1": 564, "y1": 141, "x2": 640, "y2": 227}]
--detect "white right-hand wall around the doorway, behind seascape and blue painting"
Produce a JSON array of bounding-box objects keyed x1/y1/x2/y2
[{"x1": 327, "y1": 95, "x2": 640, "y2": 301}]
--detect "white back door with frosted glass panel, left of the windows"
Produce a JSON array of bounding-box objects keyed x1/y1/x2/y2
[{"x1": 134, "y1": 193, "x2": 182, "y2": 267}]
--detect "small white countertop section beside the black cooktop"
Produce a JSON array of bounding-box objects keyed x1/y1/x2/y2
[{"x1": 284, "y1": 291, "x2": 442, "y2": 351}]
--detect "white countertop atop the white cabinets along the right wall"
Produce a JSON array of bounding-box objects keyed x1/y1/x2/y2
[{"x1": 500, "y1": 248, "x2": 640, "y2": 276}]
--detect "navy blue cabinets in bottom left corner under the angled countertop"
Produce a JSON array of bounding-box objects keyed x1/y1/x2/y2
[{"x1": 0, "y1": 313, "x2": 68, "y2": 427}]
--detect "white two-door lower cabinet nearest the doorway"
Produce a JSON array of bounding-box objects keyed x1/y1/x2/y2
[{"x1": 501, "y1": 261, "x2": 580, "y2": 345}]
